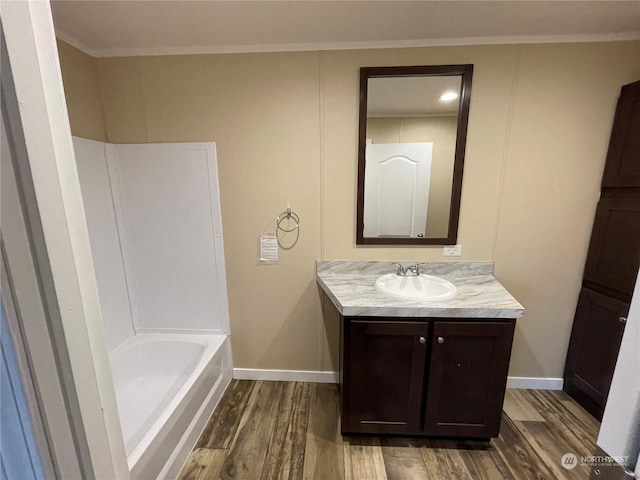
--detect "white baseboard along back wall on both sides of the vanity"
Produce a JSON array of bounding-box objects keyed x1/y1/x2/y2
[{"x1": 233, "y1": 368, "x2": 564, "y2": 390}]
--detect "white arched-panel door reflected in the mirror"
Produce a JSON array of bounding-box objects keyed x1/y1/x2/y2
[{"x1": 364, "y1": 142, "x2": 433, "y2": 237}]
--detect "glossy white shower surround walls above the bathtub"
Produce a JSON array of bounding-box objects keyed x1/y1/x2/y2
[{"x1": 74, "y1": 138, "x2": 228, "y2": 348}]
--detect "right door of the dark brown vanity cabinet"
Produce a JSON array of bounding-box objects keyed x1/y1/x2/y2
[{"x1": 424, "y1": 321, "x2": 515, "y2": 438}]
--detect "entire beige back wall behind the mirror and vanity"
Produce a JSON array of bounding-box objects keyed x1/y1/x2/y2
[{"x1": 61, "y1": 42, "x2": 640, "y2": 377}]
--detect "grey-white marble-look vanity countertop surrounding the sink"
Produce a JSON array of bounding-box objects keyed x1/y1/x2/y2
[{"x1": 316, "y1": 260, "x2": 524, "y2": 319}]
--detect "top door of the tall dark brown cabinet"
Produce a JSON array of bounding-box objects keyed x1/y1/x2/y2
[{"x1": 602, "y1": 82, "x2": 640, "y2": 188}]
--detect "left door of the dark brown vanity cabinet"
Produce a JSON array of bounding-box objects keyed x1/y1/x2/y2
[{"x1": 342, "y1": 318, "x2": 429, "y2": 434}]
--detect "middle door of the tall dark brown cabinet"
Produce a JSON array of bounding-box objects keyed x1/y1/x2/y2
[{"x1": 584, "y1": 197, "x2": 640, "y2": 300}]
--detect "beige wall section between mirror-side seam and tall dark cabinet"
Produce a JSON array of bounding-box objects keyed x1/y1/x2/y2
[{"x1": 494, "y1": 43, "x2": 640, "y2": 377}]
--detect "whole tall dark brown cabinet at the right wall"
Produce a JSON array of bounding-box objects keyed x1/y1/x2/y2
[{"x1": 564, "y1": 81, "x2": 640, "y2": 419}]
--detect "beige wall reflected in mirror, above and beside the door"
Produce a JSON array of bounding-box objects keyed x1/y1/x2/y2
[{"x1": 367, "y1": 115, "x2": 458, "y2": 237}]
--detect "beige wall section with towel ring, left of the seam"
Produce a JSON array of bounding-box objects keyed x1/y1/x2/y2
[{"x1": 104, "y1": 53, "x2": 324, "y2": 370}]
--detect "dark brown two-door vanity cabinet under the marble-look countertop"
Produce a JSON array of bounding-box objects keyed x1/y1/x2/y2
[{"x1": 340, "y1": 317, "x2": 515, "y2": 438}]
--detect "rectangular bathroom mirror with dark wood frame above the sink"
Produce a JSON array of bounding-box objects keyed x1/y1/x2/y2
[{"x1": 356, "y1": 65, "x2": 473, "y2": 245}]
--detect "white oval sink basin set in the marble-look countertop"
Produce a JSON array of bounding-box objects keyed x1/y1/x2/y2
[{"x1": 376, "y1": 273, "x2": 456, "y2": 301}]
